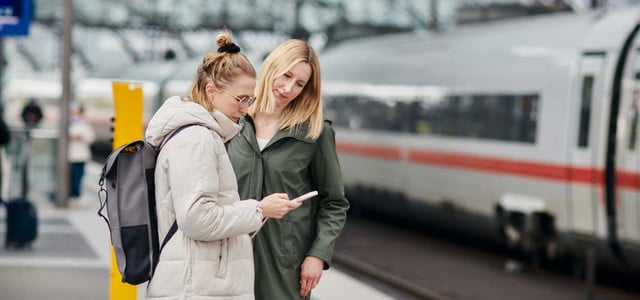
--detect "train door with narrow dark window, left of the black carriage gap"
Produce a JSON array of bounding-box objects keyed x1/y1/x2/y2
[{"x1": 569, "y1": 52, "x2": 608, "y2": 235}]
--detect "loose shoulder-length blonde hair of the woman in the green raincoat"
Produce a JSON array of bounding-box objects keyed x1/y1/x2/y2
[{"x1": 249, "y1": 39, "x2": 323, "y2": 139}]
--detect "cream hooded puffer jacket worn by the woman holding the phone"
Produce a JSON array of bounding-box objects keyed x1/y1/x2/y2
[{"x1": 145, "y1": 97, "x2": 262, "y2": 300}]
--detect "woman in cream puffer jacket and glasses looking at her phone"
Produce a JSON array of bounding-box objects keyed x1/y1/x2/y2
[{"x1": 145, "y1": 31, "x2": 298, "y2": 300}]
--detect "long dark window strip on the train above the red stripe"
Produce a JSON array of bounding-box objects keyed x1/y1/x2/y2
[{"x1": 325, "y1": 94, "x2": 539, "y2": 143}]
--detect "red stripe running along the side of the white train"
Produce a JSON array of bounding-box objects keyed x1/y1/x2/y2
[{"x1": 336, "y1": 142, "x2": 640, "y2": 190}]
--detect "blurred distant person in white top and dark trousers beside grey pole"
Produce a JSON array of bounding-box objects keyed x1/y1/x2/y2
[{"x1": 68, "y1": 103, "x2": 96, "y2": 206}]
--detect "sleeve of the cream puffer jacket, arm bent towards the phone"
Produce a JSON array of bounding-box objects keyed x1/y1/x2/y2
[{"x1": 163, "y1": 126, "x2": 262, "y2": 241}]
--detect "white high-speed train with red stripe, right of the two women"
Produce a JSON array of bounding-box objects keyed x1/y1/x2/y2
[{"x1": 320, "y1": 6, "x2": 640, "y2": 274}]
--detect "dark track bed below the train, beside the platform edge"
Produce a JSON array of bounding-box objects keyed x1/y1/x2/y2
[{"x1": 334, "y1": 216, "x2": 640, "y2": 300}]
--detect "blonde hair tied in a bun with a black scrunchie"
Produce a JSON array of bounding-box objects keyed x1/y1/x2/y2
[{"x1": 188, "y1": 29, "x2": 256, "y2": 111}]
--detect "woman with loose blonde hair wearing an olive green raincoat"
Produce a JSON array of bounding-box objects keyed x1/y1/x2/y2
[{"x1": 228, "y1": 40, "x2": 349, "y2": 300}]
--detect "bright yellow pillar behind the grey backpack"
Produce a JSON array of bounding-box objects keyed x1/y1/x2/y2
[{"x1": 109, "y1": 82, "x2": 143, "y2": 300}]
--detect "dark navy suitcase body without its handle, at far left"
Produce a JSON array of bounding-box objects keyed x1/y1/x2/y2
[{"x1": 5, "y1": 198, "x2": 38, "y2": 248}]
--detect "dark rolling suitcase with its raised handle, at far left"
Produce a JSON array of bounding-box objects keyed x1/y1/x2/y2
[{"x1": 2, "y1": 131, "x2": 38, "y2": 248}]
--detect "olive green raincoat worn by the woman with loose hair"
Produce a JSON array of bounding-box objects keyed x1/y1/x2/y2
[{"x1": 228, "y1": 116, "x2": 349, "y2": 300}]
